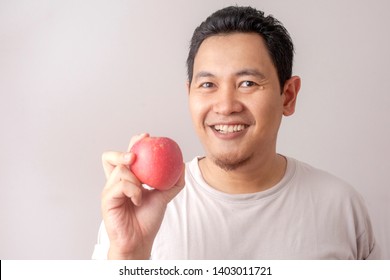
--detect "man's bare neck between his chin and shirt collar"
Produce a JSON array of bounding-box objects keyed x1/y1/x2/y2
[{"x1": 199, "y1": 153, "x2": 287, "y2": 194}]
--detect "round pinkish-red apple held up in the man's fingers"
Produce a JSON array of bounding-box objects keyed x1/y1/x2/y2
[{"x1": 130, "y1": 137, "x2": 183, "y2": 190}]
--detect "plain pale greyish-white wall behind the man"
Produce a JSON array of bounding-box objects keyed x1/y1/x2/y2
[{"x1": 0, "y1": 0, "x2": 390, "y2": 259}]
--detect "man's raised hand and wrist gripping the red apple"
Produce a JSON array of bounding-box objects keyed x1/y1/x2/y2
[{"x1": 102, "y1": 134, "x2": 184, "y2": 259}]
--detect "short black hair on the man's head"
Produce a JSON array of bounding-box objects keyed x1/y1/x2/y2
[{"x1": 187, "y1": 6, "x2": 294, "y2": 89}]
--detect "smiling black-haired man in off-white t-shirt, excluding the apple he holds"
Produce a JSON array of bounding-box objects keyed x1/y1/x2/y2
[{"x1": 93, "y1": 7, "x2": 379, "y2": 259}]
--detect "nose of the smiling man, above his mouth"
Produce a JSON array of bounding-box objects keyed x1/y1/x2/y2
[{"x1": 213, "y1": 87, "x2": 243, "y2": 116}]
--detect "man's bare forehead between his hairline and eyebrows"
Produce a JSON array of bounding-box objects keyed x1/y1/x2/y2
[{"x1": 194, "y1": 33, "x2": 274, "y2": 72}]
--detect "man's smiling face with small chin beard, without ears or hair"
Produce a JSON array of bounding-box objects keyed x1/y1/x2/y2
[{"x1": 188, "y1": 33, "x2": 285, "y2": 170}]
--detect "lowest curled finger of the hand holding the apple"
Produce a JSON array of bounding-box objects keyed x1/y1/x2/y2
[{"x1": 102, "y1": 177, "x2": 142, "y2": 210}]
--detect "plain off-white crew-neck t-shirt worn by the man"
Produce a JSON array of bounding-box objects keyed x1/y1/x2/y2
[{"x1": 92, "y1": 158, "x2": 380, "y2": 260}]
